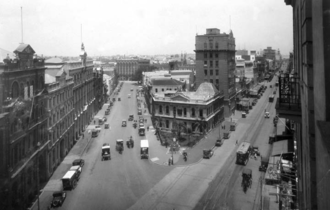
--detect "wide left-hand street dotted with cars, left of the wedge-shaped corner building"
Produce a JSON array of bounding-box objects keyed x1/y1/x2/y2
[{"x1": 56, "y1": 83, "x2": 171, "y2": 210}]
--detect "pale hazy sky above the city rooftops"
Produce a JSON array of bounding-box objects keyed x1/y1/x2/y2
[{"x1": 0, "y1": 0, "x2": 293, "y2": 56}]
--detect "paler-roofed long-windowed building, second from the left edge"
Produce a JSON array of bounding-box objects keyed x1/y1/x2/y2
[{"x1": 45, "y1": 65, "x2": 75, "y2": 177}]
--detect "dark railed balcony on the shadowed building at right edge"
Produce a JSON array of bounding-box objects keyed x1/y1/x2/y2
[{"x1": 275, "y1": 74, "x2": 301, "y2": 122}]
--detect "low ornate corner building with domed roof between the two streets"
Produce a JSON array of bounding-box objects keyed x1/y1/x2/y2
[{"x1": 152, "y1": 82, "x2": 224, "y2": 133}]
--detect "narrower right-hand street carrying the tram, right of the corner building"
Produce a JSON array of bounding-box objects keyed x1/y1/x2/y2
[{"x1": 195, "y1": 78, "x2": 284, "y2": 210}]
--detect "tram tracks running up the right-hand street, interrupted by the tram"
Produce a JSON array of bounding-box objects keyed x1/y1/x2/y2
[{"x1": 195, "y1": 90, "x2": 272, "y2": 210}]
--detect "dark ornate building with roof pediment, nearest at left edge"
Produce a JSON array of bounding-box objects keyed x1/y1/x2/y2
[{"x1": 0, "y1": 44, "x2": 48, "y2": 209}]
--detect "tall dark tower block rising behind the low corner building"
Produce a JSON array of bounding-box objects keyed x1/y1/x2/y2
[{"x1": 195, "y1": 28, "x2": 236, "y2": 117}]
